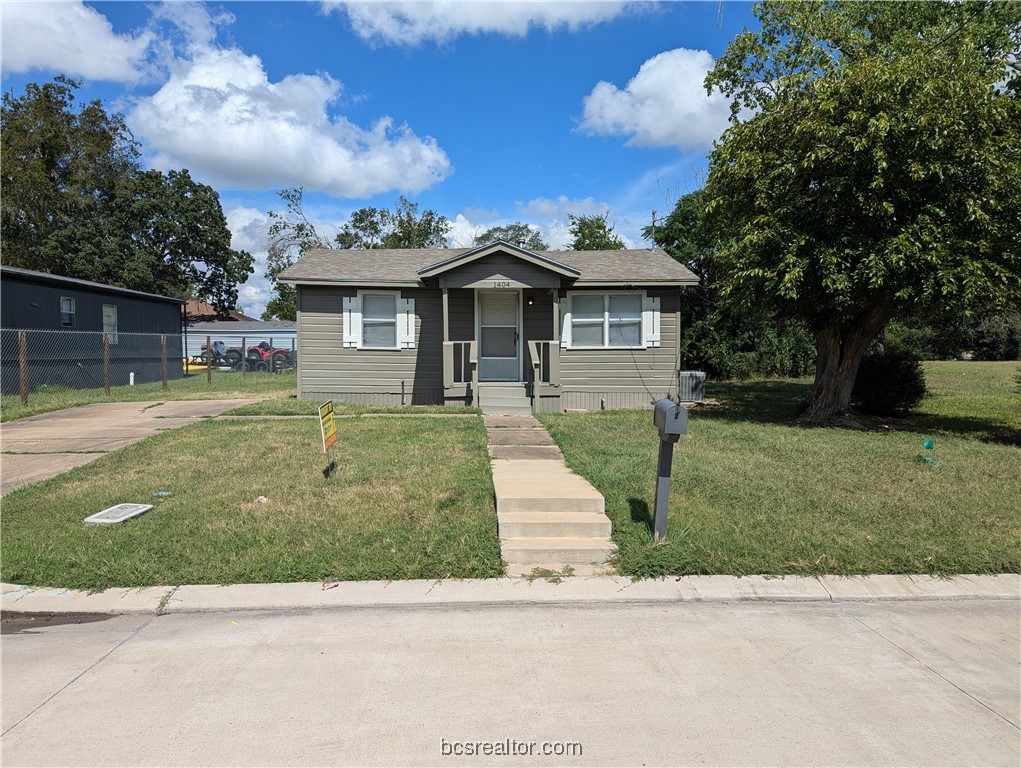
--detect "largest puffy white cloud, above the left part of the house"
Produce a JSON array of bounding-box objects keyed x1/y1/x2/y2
[{"x1": 128, "y1": 46, "x2": 451, "y2": 197}]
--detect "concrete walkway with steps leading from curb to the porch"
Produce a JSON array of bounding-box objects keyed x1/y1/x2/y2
[{"x1": 485, "y1": 416, "x2": 616, "y2": 576}]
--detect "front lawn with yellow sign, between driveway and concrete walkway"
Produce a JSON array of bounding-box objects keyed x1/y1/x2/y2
[{"x1": 0, "y1": 419, "x2": 502, "y2": 589}]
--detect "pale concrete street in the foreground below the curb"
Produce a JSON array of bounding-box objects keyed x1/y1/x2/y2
[{"x1": 2, "y1": 598, "x2": 1021, "y2": 766}]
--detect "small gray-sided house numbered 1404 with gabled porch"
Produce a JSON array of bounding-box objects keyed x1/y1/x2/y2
[{"x1": 280, "y1": 241, "x2": 697, "y2": 412}]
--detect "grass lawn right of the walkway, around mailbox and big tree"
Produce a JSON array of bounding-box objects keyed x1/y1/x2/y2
[{"x1": 540, "y1": 363, "x2": 1021, "y2": 576}]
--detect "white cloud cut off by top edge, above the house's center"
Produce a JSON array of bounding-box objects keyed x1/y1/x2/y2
[{"x1": 323, "y1": 0, "x2": 648, "y2": 45}]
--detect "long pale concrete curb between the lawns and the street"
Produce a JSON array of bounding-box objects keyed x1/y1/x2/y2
[{"x1": 0, "y1": 574, "x2": 1021, "y2": 616}]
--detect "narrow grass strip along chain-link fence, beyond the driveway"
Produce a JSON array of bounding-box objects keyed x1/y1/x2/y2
[{"x1": 0, "y1": 371, "x2": 297, "y2": 422}]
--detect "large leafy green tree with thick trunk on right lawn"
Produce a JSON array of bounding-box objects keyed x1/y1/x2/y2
[{"x1": 706, "y1": 1, "x2": 1021, "y2": 421}]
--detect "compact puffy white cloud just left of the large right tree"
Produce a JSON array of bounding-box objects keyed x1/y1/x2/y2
[{"x1": 581, "y1": 48, "x2": 730, "y2": 149}]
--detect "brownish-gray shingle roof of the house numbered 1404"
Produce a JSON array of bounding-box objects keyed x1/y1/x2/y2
[{"x1": 279, "y1": 243, "x2": 698, "y2": 287}]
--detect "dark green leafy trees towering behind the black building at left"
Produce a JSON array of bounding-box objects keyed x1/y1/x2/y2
[{"x1": 0, "y1": 77, "x2": 252, "y2": 311}]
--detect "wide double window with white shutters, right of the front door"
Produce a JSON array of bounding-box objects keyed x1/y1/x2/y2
[{"x1": 561, "y1": 291, "x2": 660, "y2": 348}]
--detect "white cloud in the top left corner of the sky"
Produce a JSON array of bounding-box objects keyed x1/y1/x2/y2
[{"x1": 0, "y1": 0, "x2": 152, "y2": 83}]
